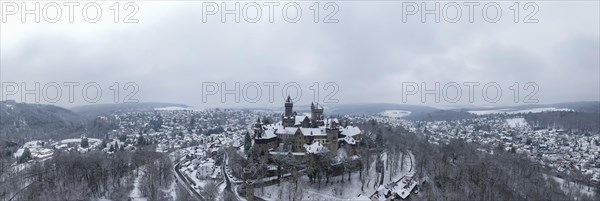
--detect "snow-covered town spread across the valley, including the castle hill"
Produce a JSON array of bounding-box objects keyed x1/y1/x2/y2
[{"x1": 10, "y1": 103, "x2": 600, "y2": 200}]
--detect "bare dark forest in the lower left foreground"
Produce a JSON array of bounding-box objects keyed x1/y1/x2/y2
[{"x1": 0, "y1": 146, "x2": 184, "y2": 200}]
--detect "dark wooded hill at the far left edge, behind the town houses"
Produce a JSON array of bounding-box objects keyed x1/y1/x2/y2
[{"x1": 0, "y1": 100, "x2": 85, "y2": 140}]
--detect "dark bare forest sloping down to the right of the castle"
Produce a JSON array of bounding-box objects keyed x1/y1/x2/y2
[{"x1": 361, "y1": 121, "x2": 600, "y2": 200}]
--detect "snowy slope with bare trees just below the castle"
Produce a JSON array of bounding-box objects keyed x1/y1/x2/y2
[{"x1": 254, "y1": 153, "x2": 414, "y2": 200}]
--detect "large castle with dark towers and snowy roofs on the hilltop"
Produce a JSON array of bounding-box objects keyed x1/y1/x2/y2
[{"x1": 254, "y1": 96, "x2": 362, "y2": 154}]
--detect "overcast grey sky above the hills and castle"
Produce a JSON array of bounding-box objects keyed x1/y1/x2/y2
[{"x1": 0, "y1": 1, "x2": 600, "y2": 107}]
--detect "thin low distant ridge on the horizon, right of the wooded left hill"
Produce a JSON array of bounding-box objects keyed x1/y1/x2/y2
[{"x1": 71, "y1": 103, "x2": 189, "y2": 120}]
